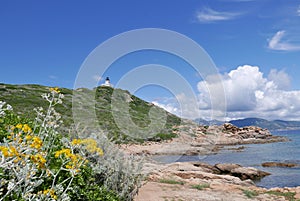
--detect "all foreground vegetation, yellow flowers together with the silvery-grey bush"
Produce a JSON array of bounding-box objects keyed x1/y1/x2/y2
[{"x1": 0, "y1": 88, "x2": 143, "y2": 201}]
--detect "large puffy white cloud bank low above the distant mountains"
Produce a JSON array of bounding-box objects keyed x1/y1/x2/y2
[{"x1": 155, "y1": 65, "x2": 300, "y2": 120}]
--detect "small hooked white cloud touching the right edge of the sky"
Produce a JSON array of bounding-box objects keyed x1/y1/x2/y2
[{"x1": 268, "y1": 30, "x2": 300, "y2": 51}]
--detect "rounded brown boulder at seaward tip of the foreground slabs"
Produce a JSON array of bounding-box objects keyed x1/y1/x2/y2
[{"x1": 230, "y1": 167, "x2": 270, "y2": 180}]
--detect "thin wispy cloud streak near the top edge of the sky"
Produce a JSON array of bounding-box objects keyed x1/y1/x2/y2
[{"x1": 196, "y1": 8, "x2": 240, "y2": 23}]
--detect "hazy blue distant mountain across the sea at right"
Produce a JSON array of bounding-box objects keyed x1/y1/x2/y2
[{"x1": 229, "y1": 118, "x2": 300, "y2": 130}]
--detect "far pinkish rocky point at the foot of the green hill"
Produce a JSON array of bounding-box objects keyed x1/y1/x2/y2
[{"x1": 121, "y1": 123, "x2": 288, "y2": 155}]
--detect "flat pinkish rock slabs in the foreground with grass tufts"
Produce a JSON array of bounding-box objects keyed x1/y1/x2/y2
[{"x1": 134, "y1": 162, "x2": 300, "y2": 201}]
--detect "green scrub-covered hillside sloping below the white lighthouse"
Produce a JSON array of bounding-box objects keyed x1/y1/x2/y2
[{"x1": 0, "y1": 84, "x2": 181, "y2": 142}]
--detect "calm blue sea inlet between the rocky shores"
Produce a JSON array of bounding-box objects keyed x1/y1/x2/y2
[{"x1": 156, "y1": 130, "x2": 300, "y2": 188}]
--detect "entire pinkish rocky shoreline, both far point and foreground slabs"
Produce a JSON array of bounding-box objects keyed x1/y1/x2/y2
[{"x1": 121, "y1": 124, "x2": 300, "y2": 201}]
